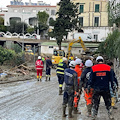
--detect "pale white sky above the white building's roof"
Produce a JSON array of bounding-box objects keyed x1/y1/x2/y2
[{"x1": 0, "y1": 0, "x2": 60, "y2": 8}]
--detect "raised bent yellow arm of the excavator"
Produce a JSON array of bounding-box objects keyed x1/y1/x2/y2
[{"x1": 67, "y1": 37, "x2": 86, "y2": 59}]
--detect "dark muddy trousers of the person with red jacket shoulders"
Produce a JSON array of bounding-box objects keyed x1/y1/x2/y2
[{"x1": 92, "y1": 90, "x2": 111, "y2": 116}]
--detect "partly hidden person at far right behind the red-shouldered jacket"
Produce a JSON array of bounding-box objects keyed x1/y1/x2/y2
[{"x1": 108, "y1": 62, "x2": 119, "y2": 109}]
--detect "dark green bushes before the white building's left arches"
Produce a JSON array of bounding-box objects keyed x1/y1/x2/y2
[{"x1": 8, "y1": 20, "x2": 27, "y2": 33}]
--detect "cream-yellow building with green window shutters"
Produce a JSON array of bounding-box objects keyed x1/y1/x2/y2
[{"x1": 69, "y1": 0, "x2": 112, "y2": 41}]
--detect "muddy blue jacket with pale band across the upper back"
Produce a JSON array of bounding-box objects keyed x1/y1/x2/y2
[{"x1": 64, "y1": 68, "x2": 78, "y2": 91}]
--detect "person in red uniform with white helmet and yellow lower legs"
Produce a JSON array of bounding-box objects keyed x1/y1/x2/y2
[{"x1": 35, "y1": 56, "x2": 43, "y2": 81}]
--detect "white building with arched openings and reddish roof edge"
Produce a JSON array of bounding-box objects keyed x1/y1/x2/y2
[{"x1": 4, "y1": 0, "x2": 56, "y2": 26}]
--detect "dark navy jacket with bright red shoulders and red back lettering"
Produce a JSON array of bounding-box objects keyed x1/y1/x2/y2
[{"x1": 88, "y1": 63, "x2": 114, "y2": 91}]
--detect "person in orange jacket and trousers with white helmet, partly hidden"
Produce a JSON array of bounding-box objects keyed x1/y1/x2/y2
[{"x1": 74, "y1": 58, "x2": 82, "y2": 114}]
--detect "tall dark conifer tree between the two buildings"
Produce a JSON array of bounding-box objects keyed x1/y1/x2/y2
[{"x1": 49, "y1": 0, "x2": 79, "y2": 50}]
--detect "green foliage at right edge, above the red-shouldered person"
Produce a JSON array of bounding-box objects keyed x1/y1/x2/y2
[{"x1": 98, "y1": 30, "x2": 120, "y2": 59}]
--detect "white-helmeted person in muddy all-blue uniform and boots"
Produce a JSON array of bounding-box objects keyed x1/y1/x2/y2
[{"x1": 63, "y1": 61, "x2": 78, "y2": 118}]
